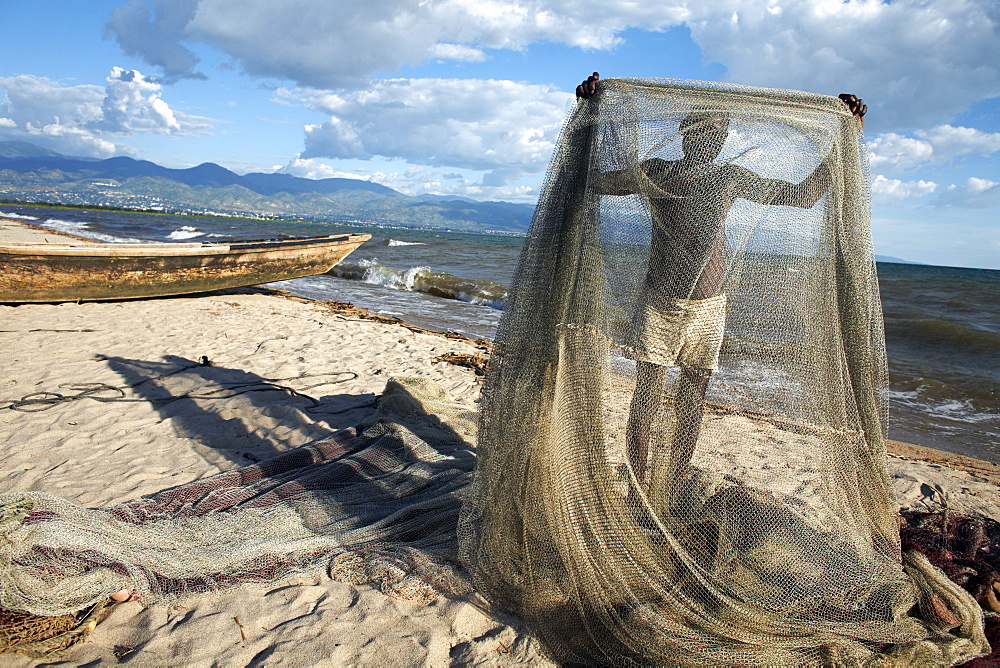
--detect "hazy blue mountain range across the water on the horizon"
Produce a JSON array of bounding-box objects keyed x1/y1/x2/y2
[{"x1": 0, "y1": 141, "x2": 534, "y2": 234}]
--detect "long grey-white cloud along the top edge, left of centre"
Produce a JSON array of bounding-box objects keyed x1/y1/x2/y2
[{"x1": 106, "y1": 0, "x2": 664, "y2": 88}]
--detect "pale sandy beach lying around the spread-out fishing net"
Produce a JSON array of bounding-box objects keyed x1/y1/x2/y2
[{"x1": 0, "y1": 221, "x2": 1000, "y2": 666}]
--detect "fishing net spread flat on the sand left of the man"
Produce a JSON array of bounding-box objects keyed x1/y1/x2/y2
[{"x1": 0, "y1": 378, "x2": 475, "y2": 616}]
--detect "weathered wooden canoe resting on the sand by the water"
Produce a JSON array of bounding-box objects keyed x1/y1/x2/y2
[{"x1": 0, "y1": 234, "x2": 371, "y2": 303}]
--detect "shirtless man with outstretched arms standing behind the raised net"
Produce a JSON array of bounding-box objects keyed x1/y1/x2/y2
[{"x1": 588, "y1": 87, "x2": 868, "y2": 505}]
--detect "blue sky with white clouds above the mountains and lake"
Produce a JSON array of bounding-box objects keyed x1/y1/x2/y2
[{"x1": 0, "y1": 0, "x2": 1000, "y2": 269}]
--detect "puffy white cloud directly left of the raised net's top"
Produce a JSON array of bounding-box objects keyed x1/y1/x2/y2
[{"x1": 278, "y1": 79, "x2": 570, "y2": 177}]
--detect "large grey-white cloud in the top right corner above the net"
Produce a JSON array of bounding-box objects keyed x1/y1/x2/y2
[{"x1": 687, "y1": 0, "x2": 1000, "y2": 130}]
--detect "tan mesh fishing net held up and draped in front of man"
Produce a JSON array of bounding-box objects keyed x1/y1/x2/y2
[{"x1": 459, "y1": 79, "x2": 988, "y2": 665}]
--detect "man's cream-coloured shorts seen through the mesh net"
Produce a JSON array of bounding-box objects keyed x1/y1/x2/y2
[{"x1": 623, "y1": 290, "x2": 726, "y2": 370}]
